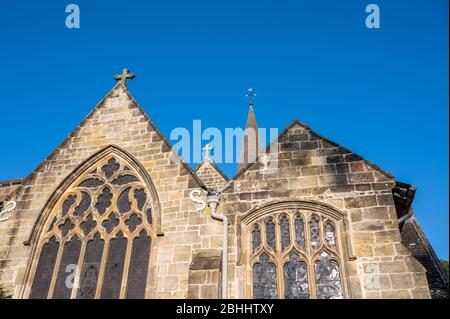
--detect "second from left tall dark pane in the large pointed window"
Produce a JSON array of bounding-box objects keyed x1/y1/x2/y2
[{"x1": 53, "y1": 237, "x2": 81, "y2": 299}]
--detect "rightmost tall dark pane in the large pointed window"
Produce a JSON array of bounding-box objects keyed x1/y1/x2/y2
[{"x1": 126, "y1": 230, "x2": 151, "y2": 299}]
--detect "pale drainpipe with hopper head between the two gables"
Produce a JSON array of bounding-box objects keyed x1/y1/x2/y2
[{"x1": 206, "y1": 189, "x2": 228, "y2": 299}]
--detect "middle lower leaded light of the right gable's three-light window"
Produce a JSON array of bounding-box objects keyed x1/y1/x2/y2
[{"x1": 283, "y1": 254, "x2": 309, "y2": 299}]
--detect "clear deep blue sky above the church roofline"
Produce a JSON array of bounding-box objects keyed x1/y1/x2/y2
[{"x1": 0, "y1": 0, "x2": 449, "y2": 258}]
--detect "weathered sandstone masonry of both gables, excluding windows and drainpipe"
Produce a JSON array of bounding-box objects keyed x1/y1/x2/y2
[{"x1": 0, "y1": 84, "x2": 429, "y2": 298}]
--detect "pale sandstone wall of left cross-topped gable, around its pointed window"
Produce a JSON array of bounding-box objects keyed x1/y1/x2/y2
[{"x1": 0, "y1": 85, "x2": 221, "y2": 298}]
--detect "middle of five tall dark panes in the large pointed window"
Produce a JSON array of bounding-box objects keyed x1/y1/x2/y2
[{"x1": 77, "y1": 233, "x2": 105, "y2": 299}]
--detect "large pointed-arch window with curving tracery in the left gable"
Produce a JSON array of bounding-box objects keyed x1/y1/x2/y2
[{"x1": 30, "y1": 154, "x2": 156, "y2": 299}]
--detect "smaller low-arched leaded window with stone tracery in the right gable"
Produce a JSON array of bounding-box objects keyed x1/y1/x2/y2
[{"x1": 248, "y1": 209, "x2": 344, "y2": 299}]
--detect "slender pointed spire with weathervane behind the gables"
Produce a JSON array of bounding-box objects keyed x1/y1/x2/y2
[{"x1": 238, "y1": 88, "x2": 263, "y2": 171}]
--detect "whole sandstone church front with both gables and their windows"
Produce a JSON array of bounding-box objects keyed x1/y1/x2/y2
[{"x1": 0, "y1": 72, "x2": 442, "y2": 298}]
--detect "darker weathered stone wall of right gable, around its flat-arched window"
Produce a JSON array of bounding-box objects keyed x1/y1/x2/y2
[{"x1": 222, "y1": 122, "x2": 430, "y2": 298}]
